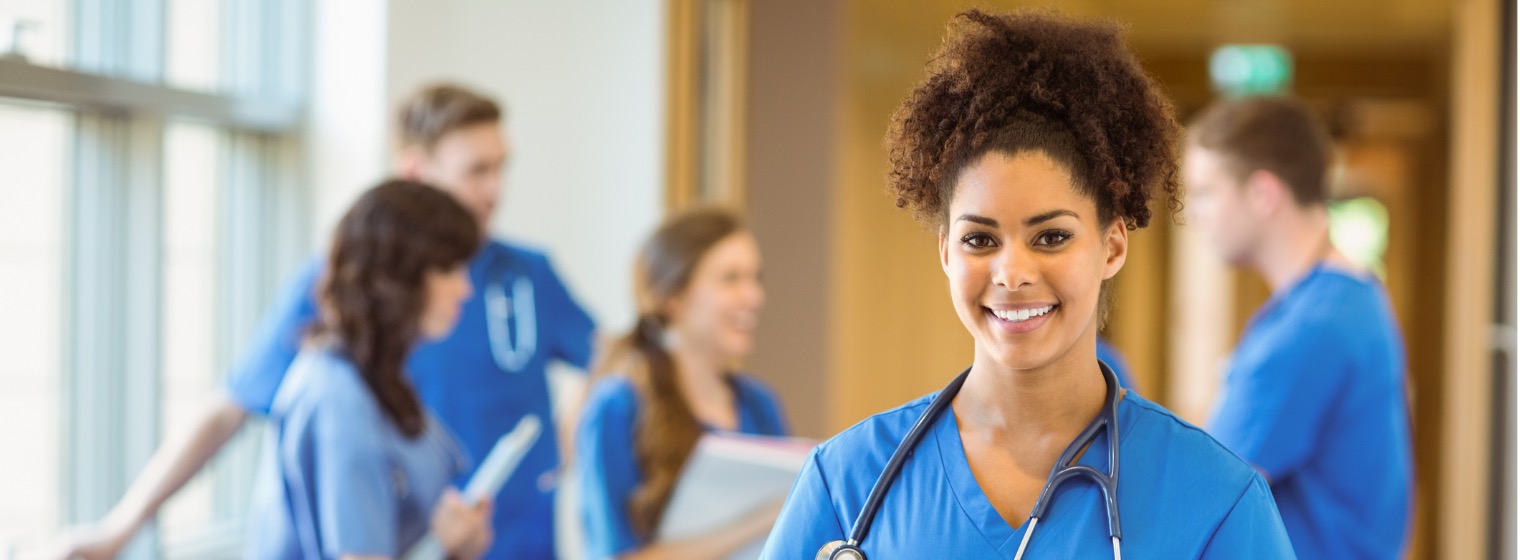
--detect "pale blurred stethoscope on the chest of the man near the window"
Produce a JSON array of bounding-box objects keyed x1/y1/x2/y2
[{"x1": 483, "y1": 249, "x2": 538, "y2": 373}]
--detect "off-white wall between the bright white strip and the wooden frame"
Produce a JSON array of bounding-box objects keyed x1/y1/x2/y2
[{"x1": 386, "y1": 0, "x2": 664, "y2": 330}]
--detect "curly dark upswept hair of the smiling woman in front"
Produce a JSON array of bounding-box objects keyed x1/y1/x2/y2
[{"x1": 886, "y1": 9, "x2": 1183, "y2": 230}]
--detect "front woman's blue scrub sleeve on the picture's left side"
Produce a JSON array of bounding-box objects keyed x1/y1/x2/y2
[{"x1": 760, "y1": 447, "x2": 845, "y2": 560}]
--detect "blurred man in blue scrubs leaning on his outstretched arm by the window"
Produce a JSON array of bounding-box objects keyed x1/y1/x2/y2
[{"x1": 52, "y1": 85, "x2": 594, "y2": 558}]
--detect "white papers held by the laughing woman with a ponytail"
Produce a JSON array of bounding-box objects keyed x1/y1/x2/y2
[{"x1": 657, "y1": 434, "x2": 818, "y2": 560}]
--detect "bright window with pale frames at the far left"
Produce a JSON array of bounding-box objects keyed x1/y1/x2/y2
[{"x1": 0, "y1": 0, "x2": 310, "y2": 558}]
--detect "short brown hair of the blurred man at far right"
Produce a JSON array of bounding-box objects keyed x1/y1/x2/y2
[{"x1": 1187, "y1": 96, "x2": 1332, "y2": 207}]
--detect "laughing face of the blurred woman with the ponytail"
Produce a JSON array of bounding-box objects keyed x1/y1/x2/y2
[{"x1": 669, "y1": 233, "x2": 765, "y2": 361}]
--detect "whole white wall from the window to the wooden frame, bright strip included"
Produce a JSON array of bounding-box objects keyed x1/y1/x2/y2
[{"x1": 307, "y1": 0, "x2": 666, "y2": 330}]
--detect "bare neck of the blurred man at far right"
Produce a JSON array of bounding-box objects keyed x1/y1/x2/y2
[{"x1": 1254, "y1": 205, "x2": 1333, "y2": 294}]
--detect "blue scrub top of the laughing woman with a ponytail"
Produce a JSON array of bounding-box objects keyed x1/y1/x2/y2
[{"x1": 575, "y1": 376, "x2": 789, "y2": 560}]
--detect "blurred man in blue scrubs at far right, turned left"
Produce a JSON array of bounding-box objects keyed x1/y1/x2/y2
[{"x1": 1184, "y1": 97, "x2": 1414, "y2": 560}]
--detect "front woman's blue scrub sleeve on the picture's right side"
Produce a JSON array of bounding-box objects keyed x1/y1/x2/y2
[{"x1": 1199, "y1": 476, "x2": 1295, "y2": 560}]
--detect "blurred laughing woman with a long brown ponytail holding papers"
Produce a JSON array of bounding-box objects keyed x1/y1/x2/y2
[{"x1": 576, "y1": 208, "x2": 787, "y2": 558}]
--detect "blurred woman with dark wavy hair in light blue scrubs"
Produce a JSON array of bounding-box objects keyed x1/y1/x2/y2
[{"x1": 248, "y1": 180, "x2": 491, "y2": 558}]
